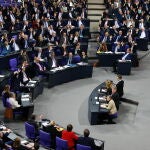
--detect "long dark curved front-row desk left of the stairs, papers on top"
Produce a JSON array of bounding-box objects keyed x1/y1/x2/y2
[{"x1": 48, "y1": 64, "x2": 93, "y2": 88}]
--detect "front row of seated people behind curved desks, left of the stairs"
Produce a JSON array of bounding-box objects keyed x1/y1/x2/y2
[{"x1": 3, "y1": 45, "x2": 88, "y2": 92}]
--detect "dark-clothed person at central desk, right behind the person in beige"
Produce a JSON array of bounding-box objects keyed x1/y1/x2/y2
[{"x1": 111, "y1": 86, "x2": 120, "y2": 110}]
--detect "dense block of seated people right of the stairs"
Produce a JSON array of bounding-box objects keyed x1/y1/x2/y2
[{"x1": 97, "y1": 0, "x2": 150, "y2": 51}]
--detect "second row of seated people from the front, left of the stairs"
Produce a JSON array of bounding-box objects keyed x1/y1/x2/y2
[{"x1": 0, "y1": 22, "x2": 88, "y2": 56}]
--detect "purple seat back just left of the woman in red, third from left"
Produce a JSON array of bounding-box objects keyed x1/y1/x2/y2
[{"x1": 56, "y1": 137, "x2": 68, "y2": 150}]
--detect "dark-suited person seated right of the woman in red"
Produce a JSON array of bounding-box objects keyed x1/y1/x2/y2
[{"x1": 77, "y1": 129, "x2": 95, "y2": 150}]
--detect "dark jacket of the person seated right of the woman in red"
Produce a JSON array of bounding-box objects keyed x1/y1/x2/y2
[{"x1": 77, "y1": 137, "x2": 95, "y2": 150}]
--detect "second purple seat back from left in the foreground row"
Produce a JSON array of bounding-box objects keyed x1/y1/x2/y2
[{"x1": 39, "y1": 130, "x2": 51, "y2": 148}]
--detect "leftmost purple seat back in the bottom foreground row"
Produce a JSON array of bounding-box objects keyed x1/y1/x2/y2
[{"x1": 25, "y1": 122, "x2": 36, "y2": 140}]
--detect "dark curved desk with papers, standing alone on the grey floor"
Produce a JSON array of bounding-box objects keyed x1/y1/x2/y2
[{"x1": 88, "y1": 82, "x2": 109, "y2": 125}]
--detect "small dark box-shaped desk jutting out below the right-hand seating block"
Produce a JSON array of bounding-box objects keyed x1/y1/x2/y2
[{"x1": 117, "y1": 60, "x2": 132, "y2": 75}]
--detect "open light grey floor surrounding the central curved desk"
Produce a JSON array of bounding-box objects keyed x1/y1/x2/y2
[{"x1": 0, "y1": 50, "x2": 150, "y2": 150}]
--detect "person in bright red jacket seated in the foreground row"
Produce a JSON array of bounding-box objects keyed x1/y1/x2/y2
[{"x1": 62, "y1": 124, "x2": 78, "y2": 150}]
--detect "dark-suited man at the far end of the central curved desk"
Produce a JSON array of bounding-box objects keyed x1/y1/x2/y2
[{"x1": 116, "y1": 75, "x2": 124, "y2": 98}]
